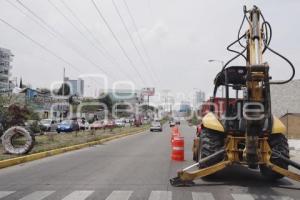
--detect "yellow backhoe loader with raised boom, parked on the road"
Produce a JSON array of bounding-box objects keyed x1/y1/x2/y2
[{"x1": 170, "y1": 6, "x2": 300, "y2": 186}]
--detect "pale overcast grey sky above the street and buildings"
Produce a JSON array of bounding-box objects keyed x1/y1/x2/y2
[{"x1": 0, "y1": 0, "x2": 300, "y2": 104}]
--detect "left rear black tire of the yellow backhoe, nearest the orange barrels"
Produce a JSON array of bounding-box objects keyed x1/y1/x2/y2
[{"x1": 198, "y1": 128, "x2": 224, "y2": 168}]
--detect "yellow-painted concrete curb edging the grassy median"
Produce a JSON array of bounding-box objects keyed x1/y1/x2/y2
[{"x1": 0, "y1": 128, "x2": 147, "y2": 169}]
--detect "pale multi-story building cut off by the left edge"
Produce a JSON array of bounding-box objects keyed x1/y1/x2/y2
[{"x1": 0, "y1": 48, "x2": 13, "y2": 93}]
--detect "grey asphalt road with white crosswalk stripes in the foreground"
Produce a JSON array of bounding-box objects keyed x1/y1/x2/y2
[{"x1": 0, "y1": 121, "x2": 300, "y2": 200}]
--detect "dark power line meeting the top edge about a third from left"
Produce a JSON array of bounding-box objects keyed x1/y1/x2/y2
[{"x1": 91, "y1": 0, "x2": 146, "y2": 85}]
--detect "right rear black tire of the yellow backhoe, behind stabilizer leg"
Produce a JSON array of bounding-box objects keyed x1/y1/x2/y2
[{"x1": 260, "y1": 133, "x2": 290, "y2": 180}]
